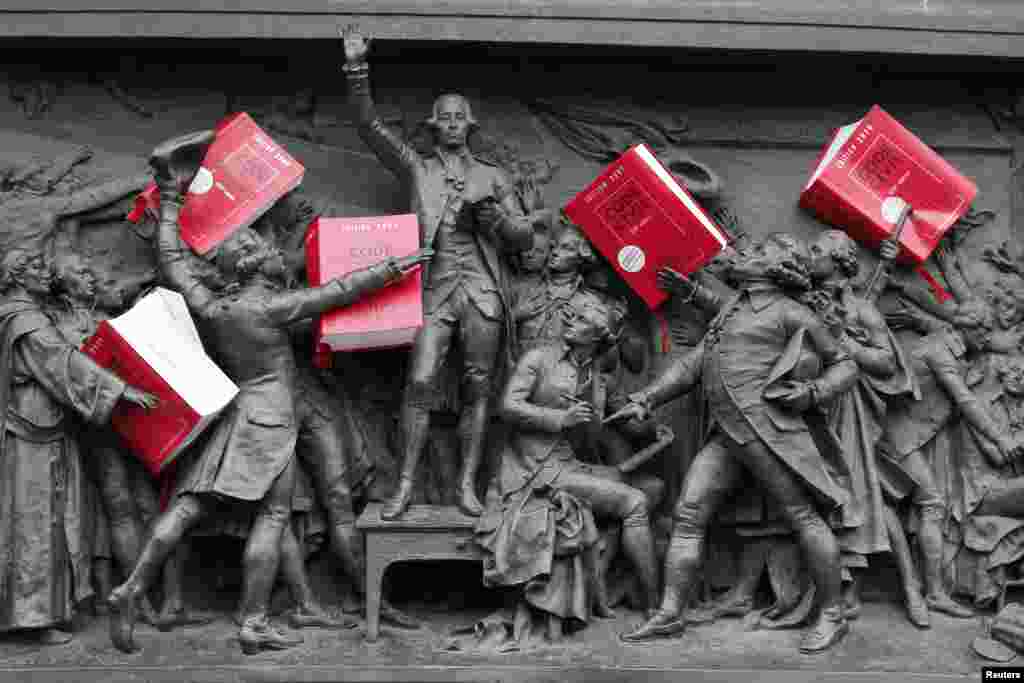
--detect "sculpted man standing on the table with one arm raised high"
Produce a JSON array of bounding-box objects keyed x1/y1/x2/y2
[{"x1": 343, "y1": 27, "x2": 534, "y2": 519}]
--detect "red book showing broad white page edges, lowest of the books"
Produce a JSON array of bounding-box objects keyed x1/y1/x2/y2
[{"x1": 82, "y1": 288, "x2": 239, "y2": 476}]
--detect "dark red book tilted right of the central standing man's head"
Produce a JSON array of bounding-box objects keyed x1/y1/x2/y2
[{"x1": 563, "y1": 144, "x2": 728, "y2": 309}]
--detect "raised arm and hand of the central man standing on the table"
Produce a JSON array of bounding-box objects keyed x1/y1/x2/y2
[{"x1": 341, "y1": 26, "x2": 420, "y2": 179}]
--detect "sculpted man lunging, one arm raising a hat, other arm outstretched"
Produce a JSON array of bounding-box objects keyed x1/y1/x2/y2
[{"x1": 111, "y1": 132, "x2": 426, "y2": 653}]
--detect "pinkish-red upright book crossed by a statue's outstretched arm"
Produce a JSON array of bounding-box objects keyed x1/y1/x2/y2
[{"x1": 306, "y1": 214, "x2": 423, "y2": 366}]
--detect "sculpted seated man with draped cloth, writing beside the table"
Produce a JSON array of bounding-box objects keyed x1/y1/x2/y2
[{"x1": 476, "y1": 296, "x2": 657, "y2": 638}]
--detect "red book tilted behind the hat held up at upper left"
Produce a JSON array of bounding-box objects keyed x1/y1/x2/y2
[{"x1": 128, "y1": 113, "x2": 305, "y2": 254}]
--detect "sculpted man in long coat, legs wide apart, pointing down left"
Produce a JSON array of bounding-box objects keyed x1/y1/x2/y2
[{"x1": 617, "y1": 234, "x2": 857, "y2": 652}]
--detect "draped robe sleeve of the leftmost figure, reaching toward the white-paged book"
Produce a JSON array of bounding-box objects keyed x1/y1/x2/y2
[{"x1": 16, "y1": 326, "x2": 125, "y2": 425}]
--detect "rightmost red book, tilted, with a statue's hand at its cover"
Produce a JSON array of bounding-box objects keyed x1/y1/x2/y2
[{"x1": 800, "y1": 105, "x2": 978, "y2": 263}]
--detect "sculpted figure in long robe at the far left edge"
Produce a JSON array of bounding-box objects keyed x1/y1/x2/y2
[{"x1": 0, "y1": 248, "x2": 157, "y2": 643}]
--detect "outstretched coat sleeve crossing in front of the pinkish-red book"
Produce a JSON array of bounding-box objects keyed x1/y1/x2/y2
[{"x1": 266, "y1": 261, "x2": 401, "y2": 326}]
